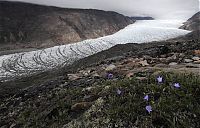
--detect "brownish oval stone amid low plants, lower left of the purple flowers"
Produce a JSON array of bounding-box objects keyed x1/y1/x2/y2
[{"x1": 71, "y1": 102, "x2": 92, "y2": 111}]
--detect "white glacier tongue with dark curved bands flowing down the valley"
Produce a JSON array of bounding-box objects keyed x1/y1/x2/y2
[{"x1": 0, "y1": 20, "x2": 190, "y2": 81}]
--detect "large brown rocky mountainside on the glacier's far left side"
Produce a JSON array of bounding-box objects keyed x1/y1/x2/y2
[{"x1": 0, "y1": 1, "x2": 134, "y2": 50}]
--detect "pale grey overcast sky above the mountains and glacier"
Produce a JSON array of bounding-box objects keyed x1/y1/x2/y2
[{"x1": 5, "y1": 0, "x2": 200, "y2": 19}]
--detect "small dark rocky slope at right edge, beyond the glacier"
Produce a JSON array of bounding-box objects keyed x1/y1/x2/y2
[{"x1": 181, "y1": 12, "x2": 200, "y2": 31}]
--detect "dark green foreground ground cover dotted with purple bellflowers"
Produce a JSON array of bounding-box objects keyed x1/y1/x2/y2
[{"x1": 0, "y1": 72, "x2": 200, "y2": 128}]
